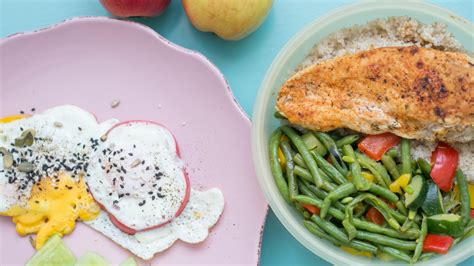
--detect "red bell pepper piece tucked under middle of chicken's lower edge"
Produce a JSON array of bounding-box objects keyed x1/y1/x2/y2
[{"x1": 357, "y1": 132, "x2": 400, "y2": 161}]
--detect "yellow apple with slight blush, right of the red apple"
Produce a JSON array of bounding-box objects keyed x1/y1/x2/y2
[{"x1": 182, "y1": 0, "x2": 273, "y2": 41}]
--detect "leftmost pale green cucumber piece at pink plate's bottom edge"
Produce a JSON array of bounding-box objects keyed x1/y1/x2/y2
[{"x1": 26, "y1": 235, "x2": 76, "y2": 266}]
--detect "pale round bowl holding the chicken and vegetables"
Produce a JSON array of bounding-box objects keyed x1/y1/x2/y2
[{"x1": 252, "y1": 1, "x2": 474, "y2": 265}]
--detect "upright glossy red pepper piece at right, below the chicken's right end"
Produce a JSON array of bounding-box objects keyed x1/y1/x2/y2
[{"x1": 430, "y1": 142, "x2": 459, "y2": 192}]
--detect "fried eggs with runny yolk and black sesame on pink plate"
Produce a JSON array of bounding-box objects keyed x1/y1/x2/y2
[{"x1": 0, "y1": 105, "x2": 225, "y2": 259}]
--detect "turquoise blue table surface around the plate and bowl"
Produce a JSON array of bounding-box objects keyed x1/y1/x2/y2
[{"x1": 0, "y1": 0, "x2": 474, "y2": 266}]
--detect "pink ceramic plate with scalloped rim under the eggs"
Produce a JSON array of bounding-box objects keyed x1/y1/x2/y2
[{"x1": 0, "y1": 18, "x2": 267, "y2": 265}]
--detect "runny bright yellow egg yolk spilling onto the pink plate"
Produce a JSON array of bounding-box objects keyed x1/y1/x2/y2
[{"x1": 1, "y1": 174, "x2": 100, "y2": 249}]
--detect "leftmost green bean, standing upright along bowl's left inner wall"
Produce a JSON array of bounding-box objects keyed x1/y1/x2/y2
[{"x1": 270, "y1": 129, "x2": 290, "y2": 202}]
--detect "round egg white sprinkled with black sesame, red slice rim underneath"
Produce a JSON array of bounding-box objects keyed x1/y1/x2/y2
[{"x1": 88, "y1": 120, "x2": 190, "y2": 234}]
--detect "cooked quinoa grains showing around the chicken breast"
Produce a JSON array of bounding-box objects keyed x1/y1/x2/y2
[{"x1": 296, "y1": 16, "x2": 474, "y2": 183}]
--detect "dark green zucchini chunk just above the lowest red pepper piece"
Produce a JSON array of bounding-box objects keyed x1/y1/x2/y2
[{"x1": 426, "y1": 213, "x2": 464, "y2": 237}]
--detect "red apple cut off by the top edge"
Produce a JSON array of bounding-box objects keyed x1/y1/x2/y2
[{"x1": 100, "y1": 0, "x2": 171, "y2": 18}]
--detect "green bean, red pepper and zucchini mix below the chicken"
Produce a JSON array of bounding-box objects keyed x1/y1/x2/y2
[{"x1": 270, "y1": 125, "x2": 474, "y2": 263}]
